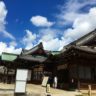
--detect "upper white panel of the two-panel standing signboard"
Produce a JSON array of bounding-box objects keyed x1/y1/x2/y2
[{"x1": 16, "y1": 69, "x2": 28, "y2": 81}]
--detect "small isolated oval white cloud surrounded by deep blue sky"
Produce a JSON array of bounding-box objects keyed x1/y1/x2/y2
[{"x1": 30, "y1": 16, "x2": 54, "y2": 27}]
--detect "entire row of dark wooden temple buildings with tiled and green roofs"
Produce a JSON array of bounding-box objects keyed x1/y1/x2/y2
[{"x1": 0, "y1": 30, "x2": 96, "y2": 89}]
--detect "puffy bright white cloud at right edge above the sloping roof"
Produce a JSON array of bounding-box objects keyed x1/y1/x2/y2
[{"x1": 64, "y1": 7, "x2": 96, "y2": 41}]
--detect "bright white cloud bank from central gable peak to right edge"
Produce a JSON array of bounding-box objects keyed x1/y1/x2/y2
[{"x1": 41, "y1": 7, "x2": 96, "y2": 50}]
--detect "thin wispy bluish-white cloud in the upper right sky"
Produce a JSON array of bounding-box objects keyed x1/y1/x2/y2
[{"x1": 57, "y1": 0, "x2": 96, "y2": 25}]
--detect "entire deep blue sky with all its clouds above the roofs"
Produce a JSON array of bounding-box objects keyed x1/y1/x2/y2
[{"x1": 0, "y1": 0, "x2": 96, "y2": 54}]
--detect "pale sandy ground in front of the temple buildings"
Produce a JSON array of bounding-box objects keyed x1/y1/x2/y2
[{"x1": 0, "y1": 83, "x2": 81, "y2": 96}]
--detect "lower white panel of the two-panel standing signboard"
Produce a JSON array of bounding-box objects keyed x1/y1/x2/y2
[{"x1": 15, "y1": 81, "x2": 26, "y2": 93}]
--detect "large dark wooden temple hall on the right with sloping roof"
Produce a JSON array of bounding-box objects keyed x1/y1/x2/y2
[{"x1": 54, "y1": 30, "x2": 96, "y2": 89}]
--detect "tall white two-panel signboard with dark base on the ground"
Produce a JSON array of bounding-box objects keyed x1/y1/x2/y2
[{"x1": 14, "y1": 69, "x2": 28, "y2": 96}]
